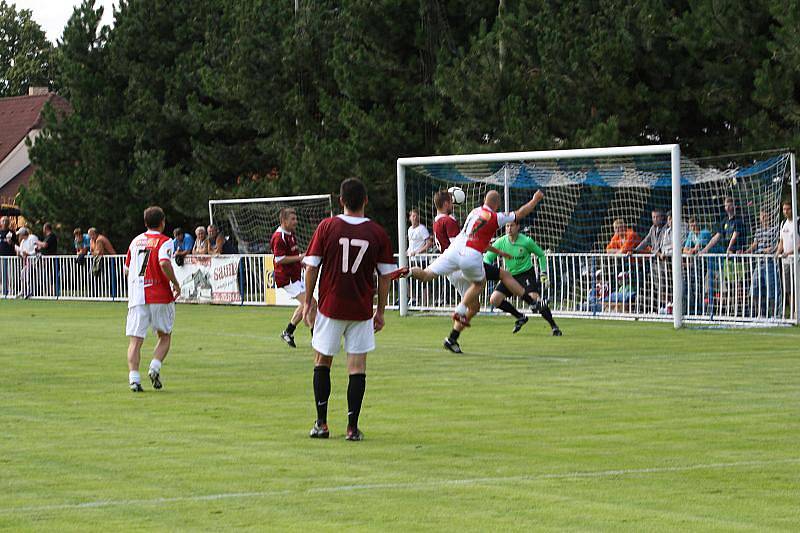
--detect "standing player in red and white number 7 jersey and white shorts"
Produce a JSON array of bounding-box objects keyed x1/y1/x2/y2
[{"x1": 125, "y1": 206, "x2": 181, "y2": 392}]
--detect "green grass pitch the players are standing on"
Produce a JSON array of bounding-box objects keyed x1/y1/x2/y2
[{"x1": 0, "y1": 301, "x2": 800, "y2": 531}]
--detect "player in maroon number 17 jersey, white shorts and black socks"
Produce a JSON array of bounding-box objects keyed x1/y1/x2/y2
[{"x1": 303, "y1": 178, "x2": 397, "y2": 441}]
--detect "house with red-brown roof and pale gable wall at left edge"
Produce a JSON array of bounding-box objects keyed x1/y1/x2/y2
[{"x1": 0, "y1": 87, "x2": 70, "y2": 204}]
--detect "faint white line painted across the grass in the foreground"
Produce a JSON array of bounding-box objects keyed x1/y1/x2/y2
[{"x1": 0, "y1": 458, "x2": 800, "y2": 514}]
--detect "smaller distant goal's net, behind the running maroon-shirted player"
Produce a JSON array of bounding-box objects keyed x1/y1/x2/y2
[{"x1": 208, "y1": 194, "x2": 333, "y2": 254}]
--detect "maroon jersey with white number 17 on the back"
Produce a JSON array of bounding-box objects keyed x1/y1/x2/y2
[{"x1": 303, "y1": 215, "x2": 397, "y2": 321}]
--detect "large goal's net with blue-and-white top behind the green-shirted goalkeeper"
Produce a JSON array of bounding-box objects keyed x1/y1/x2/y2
[{"x1": 398, "y1": 145, "x2": 796, "y2": 326}]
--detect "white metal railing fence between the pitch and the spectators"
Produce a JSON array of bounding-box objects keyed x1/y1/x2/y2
[{"x1": 0, "y1": 254, "x2": 797, "y2": 324}]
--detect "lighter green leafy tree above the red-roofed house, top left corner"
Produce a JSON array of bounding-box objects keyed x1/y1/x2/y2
[{"x1": 0, "y1": 0, "x2": 52, "y2": 98}]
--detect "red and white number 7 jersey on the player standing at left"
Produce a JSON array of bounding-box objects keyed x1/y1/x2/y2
[{"x1": 125, "y1": 230, "x2": 174, "y2": 307}]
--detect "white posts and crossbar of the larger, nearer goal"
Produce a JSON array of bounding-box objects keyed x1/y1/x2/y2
[{"x1": 397, "y1": 144, "x2": 684, "y2": 329}]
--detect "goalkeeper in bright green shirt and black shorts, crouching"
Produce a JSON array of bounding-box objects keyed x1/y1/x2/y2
[{"x1": 483, "y1": 220, "x2": 561, "y2": 337}]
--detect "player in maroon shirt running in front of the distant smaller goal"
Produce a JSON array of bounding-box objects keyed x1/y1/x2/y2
[{"x1": 269, "y1": 207, "x2": 317, "y2": 348}]
